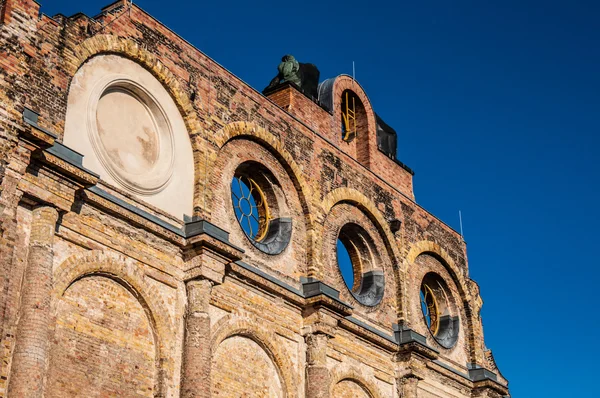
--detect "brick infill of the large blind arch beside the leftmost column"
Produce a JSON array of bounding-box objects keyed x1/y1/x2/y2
[{"x1": 45, "y1": 275, "x2": 159, "y2": 398}]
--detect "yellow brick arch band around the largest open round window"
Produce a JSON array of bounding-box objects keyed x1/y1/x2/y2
[{"x1": 202, "y1": 122, "x2": 316, "y2": 273}]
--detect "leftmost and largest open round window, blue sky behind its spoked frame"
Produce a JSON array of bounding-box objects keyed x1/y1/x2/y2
[{"x1": 231, "y1": 162, "x2": 292, "y2": 254}]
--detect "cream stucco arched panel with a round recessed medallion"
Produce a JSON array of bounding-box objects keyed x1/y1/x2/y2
[{"x1": 64, "y1": 55, "x2": 194, "y2": 218}]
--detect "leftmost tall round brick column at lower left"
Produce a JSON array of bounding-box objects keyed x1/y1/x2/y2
[{"x1": 8, "y1": 206, "x2": 58, "y2": 398}]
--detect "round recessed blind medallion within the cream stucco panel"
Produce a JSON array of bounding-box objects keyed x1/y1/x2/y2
[{"x1": 88, "y1": 79, "x2": 174, "y2": 195}]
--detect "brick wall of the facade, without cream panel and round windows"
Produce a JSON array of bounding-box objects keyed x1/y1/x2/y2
[{"x1": 0, "y1": 0, "x2": 506, "y2": 398}]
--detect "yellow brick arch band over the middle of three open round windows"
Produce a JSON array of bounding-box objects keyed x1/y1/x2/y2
[{"x1": 318, "y1": 188, "x2": 406, "y2": 318}]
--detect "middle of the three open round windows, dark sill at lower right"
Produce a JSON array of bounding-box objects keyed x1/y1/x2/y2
[{"x1": 336, "y1": 224, "x2": 385, "y2": 307}]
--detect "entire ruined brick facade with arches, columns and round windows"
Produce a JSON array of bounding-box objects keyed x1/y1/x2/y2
[{"x1": 0, "y1": 0, "x2": 508, "y2": 398}]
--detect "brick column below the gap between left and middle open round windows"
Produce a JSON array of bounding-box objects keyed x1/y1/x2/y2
[{"x1": 306, "y1": 333, "x2": 331, "y2": 398}]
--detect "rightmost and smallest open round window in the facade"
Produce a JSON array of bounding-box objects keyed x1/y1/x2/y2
[{"x1": 420, "y1": 273, "x2": 460, "y2": 348}]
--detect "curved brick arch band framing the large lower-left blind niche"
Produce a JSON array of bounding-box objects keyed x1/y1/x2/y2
[{"x1": 53, "y1": 250, "x2": 175, "y2": 396}]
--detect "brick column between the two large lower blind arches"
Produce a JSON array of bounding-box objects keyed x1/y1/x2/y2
[{"x1": 181, "y1": 279, "x2": 213, "y2": 398}]
